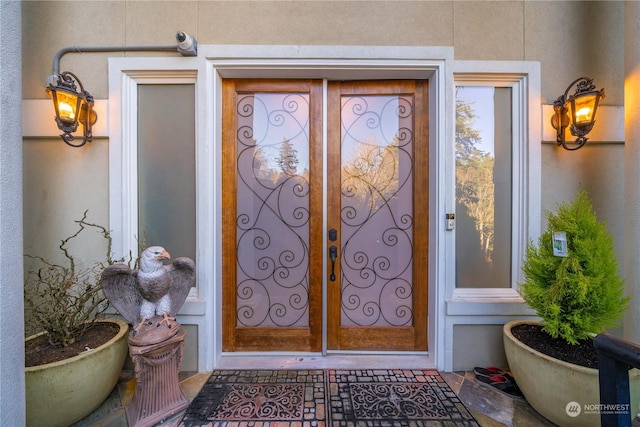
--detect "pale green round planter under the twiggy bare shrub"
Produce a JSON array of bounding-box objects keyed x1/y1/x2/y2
[{"x1": 25, "y1": 319, "x2": 129, "y2": 427}]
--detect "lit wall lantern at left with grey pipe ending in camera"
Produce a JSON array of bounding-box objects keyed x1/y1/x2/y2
[{"x1": 47, "y1": 31, "x2": 198, "y2": 147}]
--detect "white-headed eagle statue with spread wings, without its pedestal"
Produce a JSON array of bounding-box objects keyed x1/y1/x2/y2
[{"x1": 100, "y1": 246, "x2": 196, "y2": 335}]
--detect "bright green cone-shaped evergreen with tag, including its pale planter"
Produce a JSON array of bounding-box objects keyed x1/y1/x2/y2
[{"x1": 503, "y1": 191, "x2": 640, "y2": 426}]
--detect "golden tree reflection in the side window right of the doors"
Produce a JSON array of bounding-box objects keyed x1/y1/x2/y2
[{"x1": 456, "y1": 100, "x2": 495, "y2": 263}]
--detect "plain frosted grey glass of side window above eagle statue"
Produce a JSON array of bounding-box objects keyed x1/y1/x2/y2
[{"x1": 138, "y1": 84, "x2": 196, "y2": 260}]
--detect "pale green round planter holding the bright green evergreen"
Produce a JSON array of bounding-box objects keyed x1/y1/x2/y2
[{"x1": 503, "y1": 320, "x2": 640, "y2": 427}]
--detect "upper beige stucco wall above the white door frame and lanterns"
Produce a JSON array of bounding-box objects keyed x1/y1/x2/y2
[{"x1": 23, "y1": 0, "x2": 624, "y2": 105}]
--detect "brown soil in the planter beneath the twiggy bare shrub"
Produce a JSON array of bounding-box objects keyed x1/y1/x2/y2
[{"x1": 24, "y1": 323, "x2": 120, "y2": 367}]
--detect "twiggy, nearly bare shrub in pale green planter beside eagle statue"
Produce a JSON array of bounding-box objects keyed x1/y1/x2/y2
[{"x1": 24, "y1": 211, "x2": 129, "y2": 427}]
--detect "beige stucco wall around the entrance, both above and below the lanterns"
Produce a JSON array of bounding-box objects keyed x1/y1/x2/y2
[{"x1": 22, "y1": 0, "x2": 624, "y2": 369}]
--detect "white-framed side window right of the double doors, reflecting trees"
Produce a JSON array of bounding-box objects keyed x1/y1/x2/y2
[{"x1": 454, "y1": 68, "x2": 541, "y2": 298}]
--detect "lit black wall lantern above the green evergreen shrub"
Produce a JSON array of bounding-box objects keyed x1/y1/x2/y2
[{"x1": 551, "y1": 77, "x2": 604, "y2": 151}]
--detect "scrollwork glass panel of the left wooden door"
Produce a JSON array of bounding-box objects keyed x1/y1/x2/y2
[{"x1": 236, "y1": 93, "x2": 309, "y2": 327}]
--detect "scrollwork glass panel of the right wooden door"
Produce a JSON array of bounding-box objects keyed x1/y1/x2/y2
[{"x1": 341, "y1": 96, "x2": 414, "y2": 326}]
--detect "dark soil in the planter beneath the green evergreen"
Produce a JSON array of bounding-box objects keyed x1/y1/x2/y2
[{"x1": 511, "y1": 324, "x2": 598, "y2": 369}]
